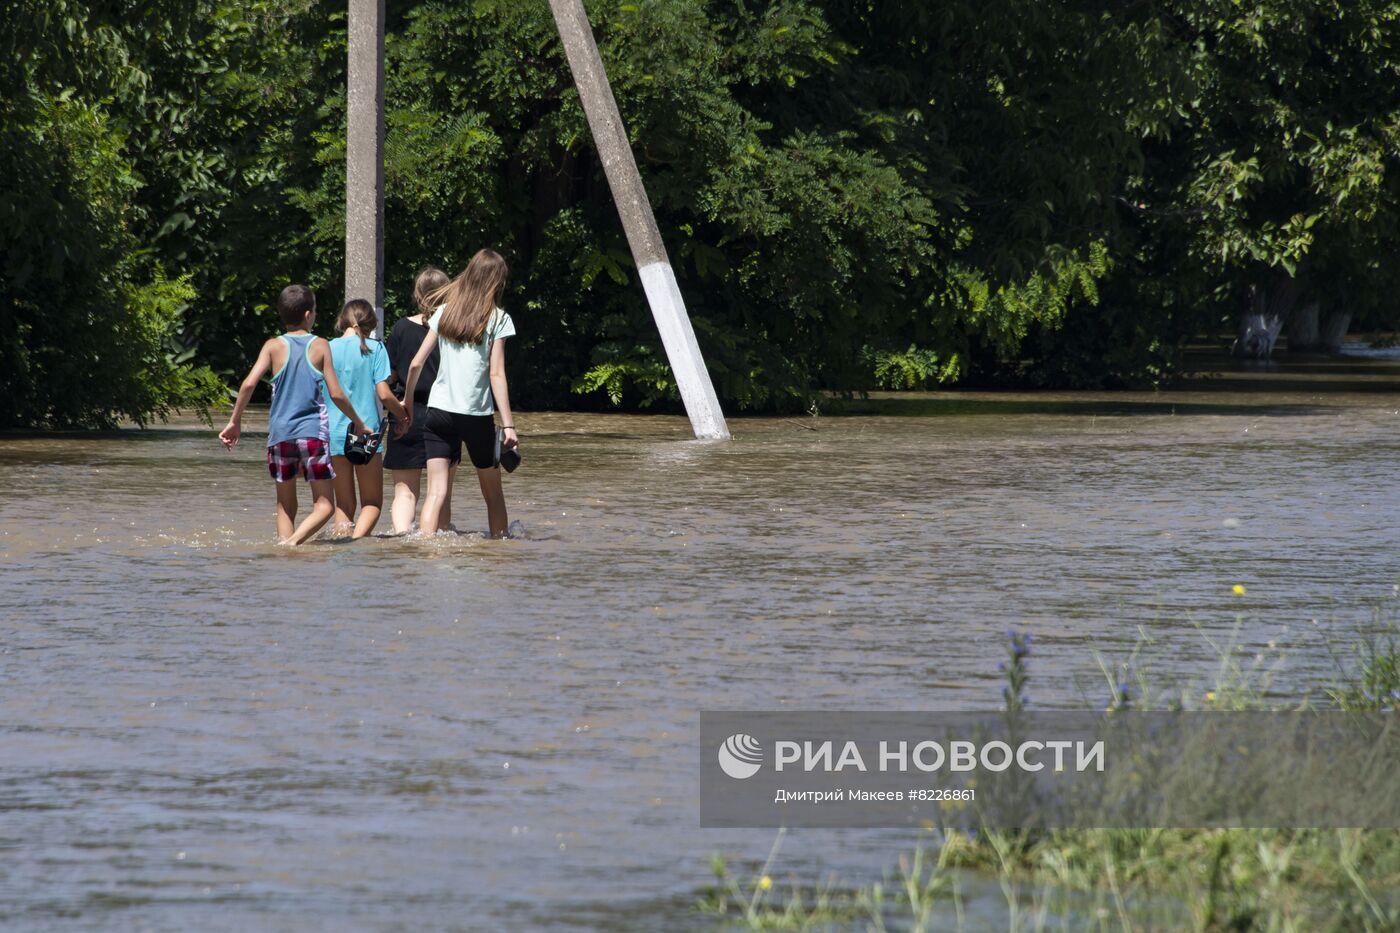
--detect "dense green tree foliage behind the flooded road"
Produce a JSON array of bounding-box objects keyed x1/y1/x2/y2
[{"x1": 0, "y1": 0, "x2": 1400, "y2": 424}]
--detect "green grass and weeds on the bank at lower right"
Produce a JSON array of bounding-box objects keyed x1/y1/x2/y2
[{"x1": 699, "y1": 587, "x2": 1400, "y2": 933}]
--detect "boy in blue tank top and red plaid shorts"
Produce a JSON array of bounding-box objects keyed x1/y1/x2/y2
[{"x1": 218, "y1": 284, "x2": 365, "y2": 545}]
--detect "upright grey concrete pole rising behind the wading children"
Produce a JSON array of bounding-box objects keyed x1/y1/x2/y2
[{"x1": 346, "y1": 0, "x2": 384, "y2": 338}]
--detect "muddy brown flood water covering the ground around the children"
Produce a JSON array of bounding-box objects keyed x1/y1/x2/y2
[{"x1": 0, "y1": 353, "x2": 1400, "y2": 930}]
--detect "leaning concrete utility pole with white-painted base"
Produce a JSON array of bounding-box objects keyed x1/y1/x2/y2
[{"x1": 543, "y1": 0, "x2": 729, "y2": 438}]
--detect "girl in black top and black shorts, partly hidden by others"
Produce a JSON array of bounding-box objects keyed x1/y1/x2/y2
[{"x1": 384, "y1": 266, "x2": 456, "y2": 535}]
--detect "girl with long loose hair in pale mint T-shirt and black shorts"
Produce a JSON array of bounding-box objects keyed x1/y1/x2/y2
[{"x1": 405, "y1": 249, "x2": 519, "y2": 538}]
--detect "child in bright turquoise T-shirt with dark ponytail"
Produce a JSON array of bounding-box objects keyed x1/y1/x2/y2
[{"x1": 330, "y1": 298, "x2": 406, "y2": 538}]
